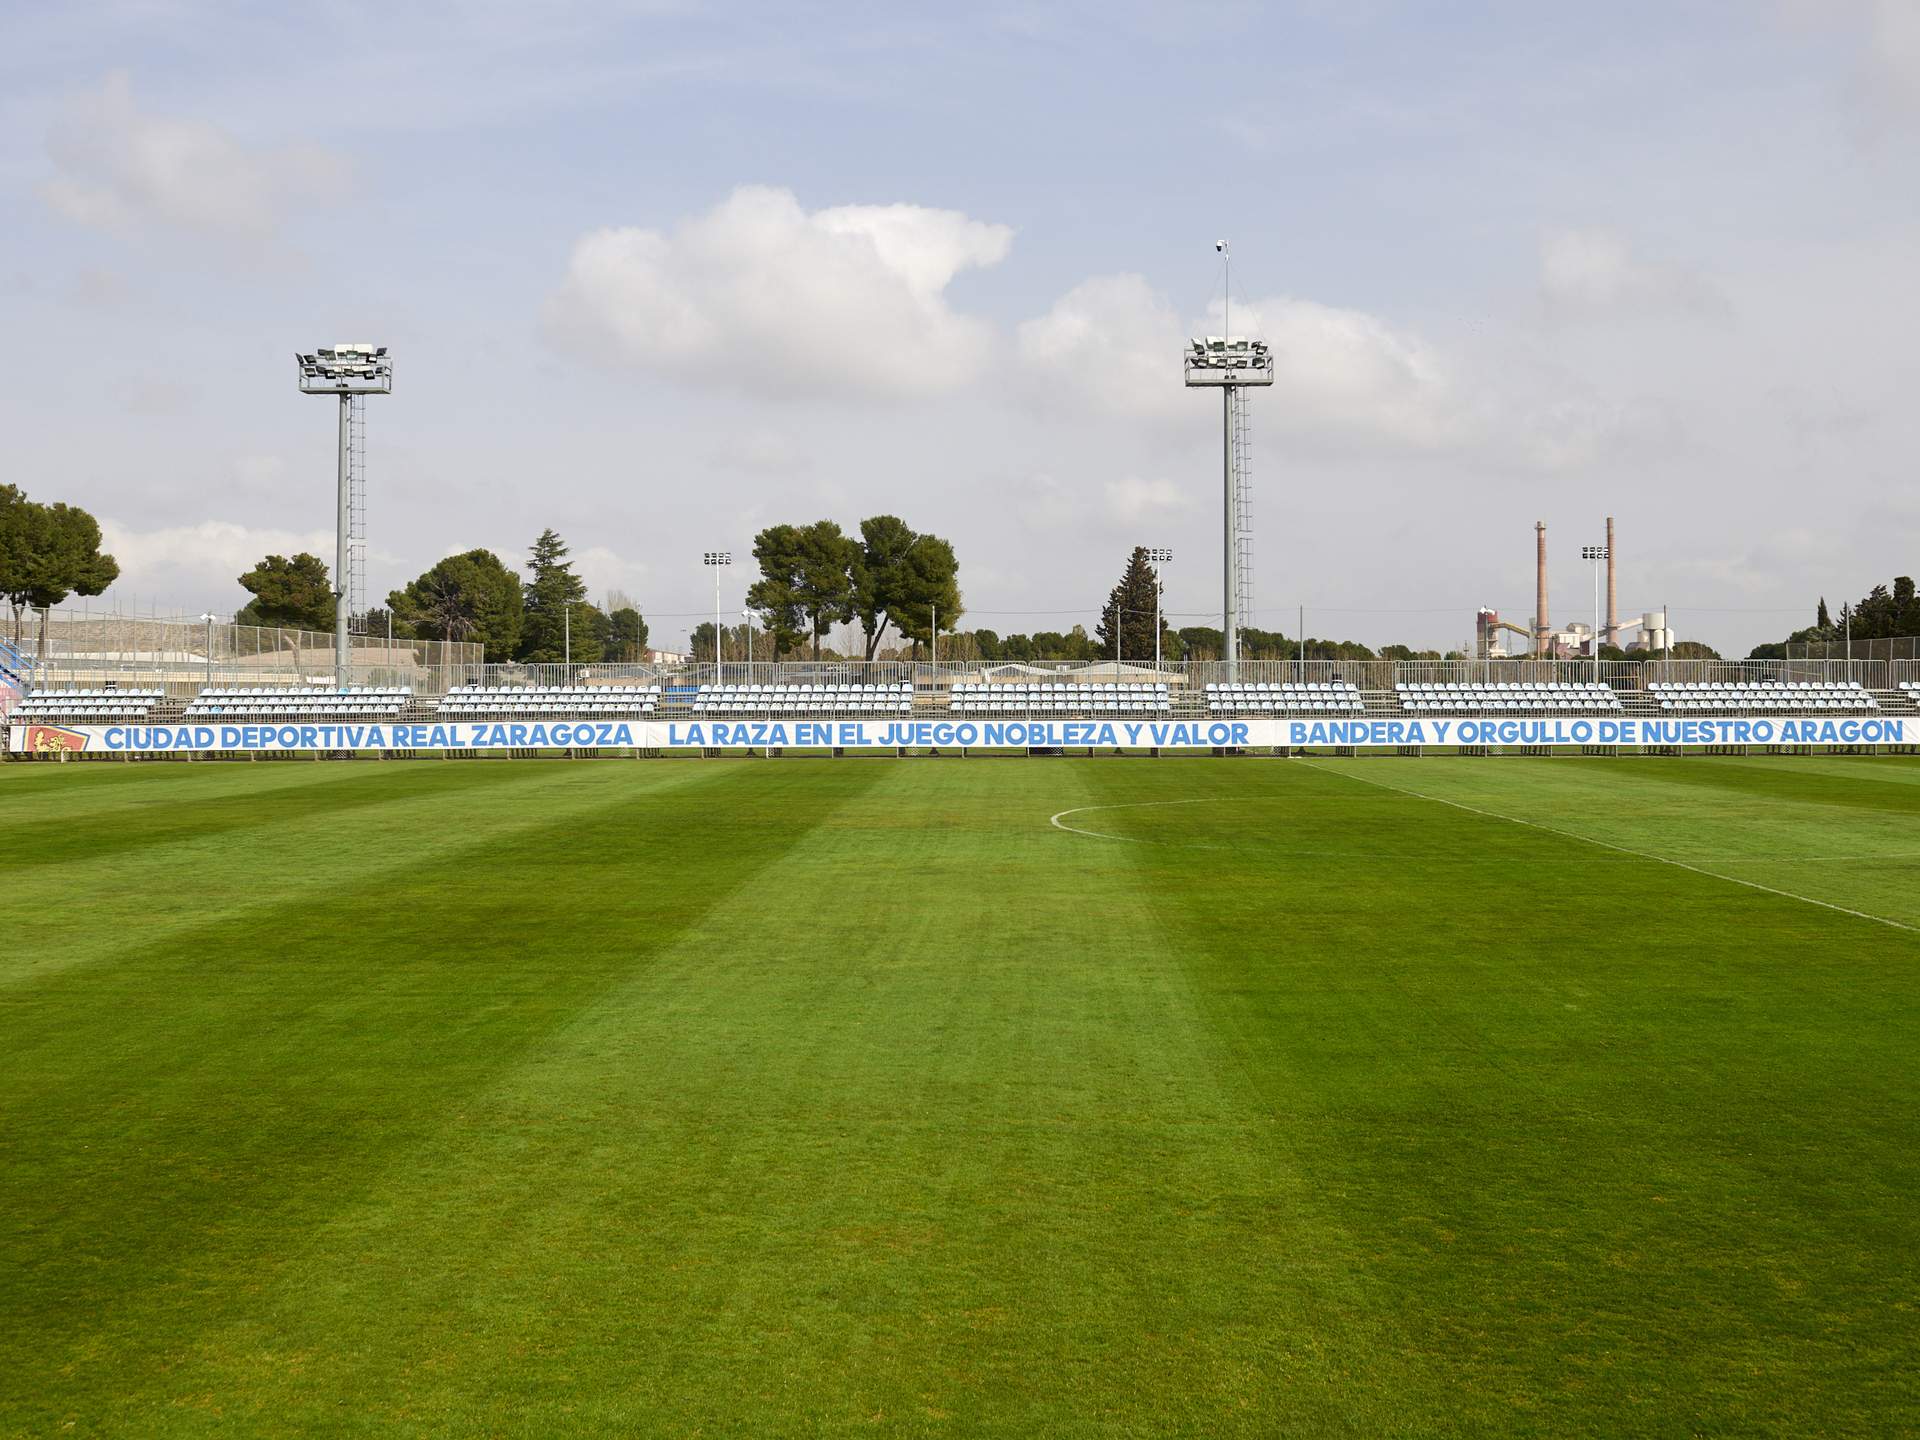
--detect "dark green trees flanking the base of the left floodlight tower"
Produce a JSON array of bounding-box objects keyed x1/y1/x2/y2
[{"x1": 234, "y1": 528, "x2": 647, "y2": 664}]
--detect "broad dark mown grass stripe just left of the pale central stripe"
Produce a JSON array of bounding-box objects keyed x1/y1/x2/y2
[{"x1": 0, "y1": 766, "x2": 890, "y2": 1428}]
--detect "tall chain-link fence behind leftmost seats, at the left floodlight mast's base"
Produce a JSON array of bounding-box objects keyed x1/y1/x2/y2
[{"x1": 19, "y1": 611, "x2": 482, "y2": 697}]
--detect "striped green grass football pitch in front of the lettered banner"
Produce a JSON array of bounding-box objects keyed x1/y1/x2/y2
[{"x1": 0, "y1": 758, "x2": 1920, "y2": 1436}]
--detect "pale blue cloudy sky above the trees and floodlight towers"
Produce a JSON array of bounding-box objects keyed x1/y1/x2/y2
[{"x1": 0, "y1": 0, "x2": 1920, "y2": 653}]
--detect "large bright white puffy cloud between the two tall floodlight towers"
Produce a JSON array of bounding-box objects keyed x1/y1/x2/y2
[{"x1": 545, "y1": 186, "x2": 1014, "y2": 396}]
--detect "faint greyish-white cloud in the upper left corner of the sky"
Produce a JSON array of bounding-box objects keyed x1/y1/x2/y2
[{"x1": 40, "y1": 71, "x2": 348, "y2": 238}]
